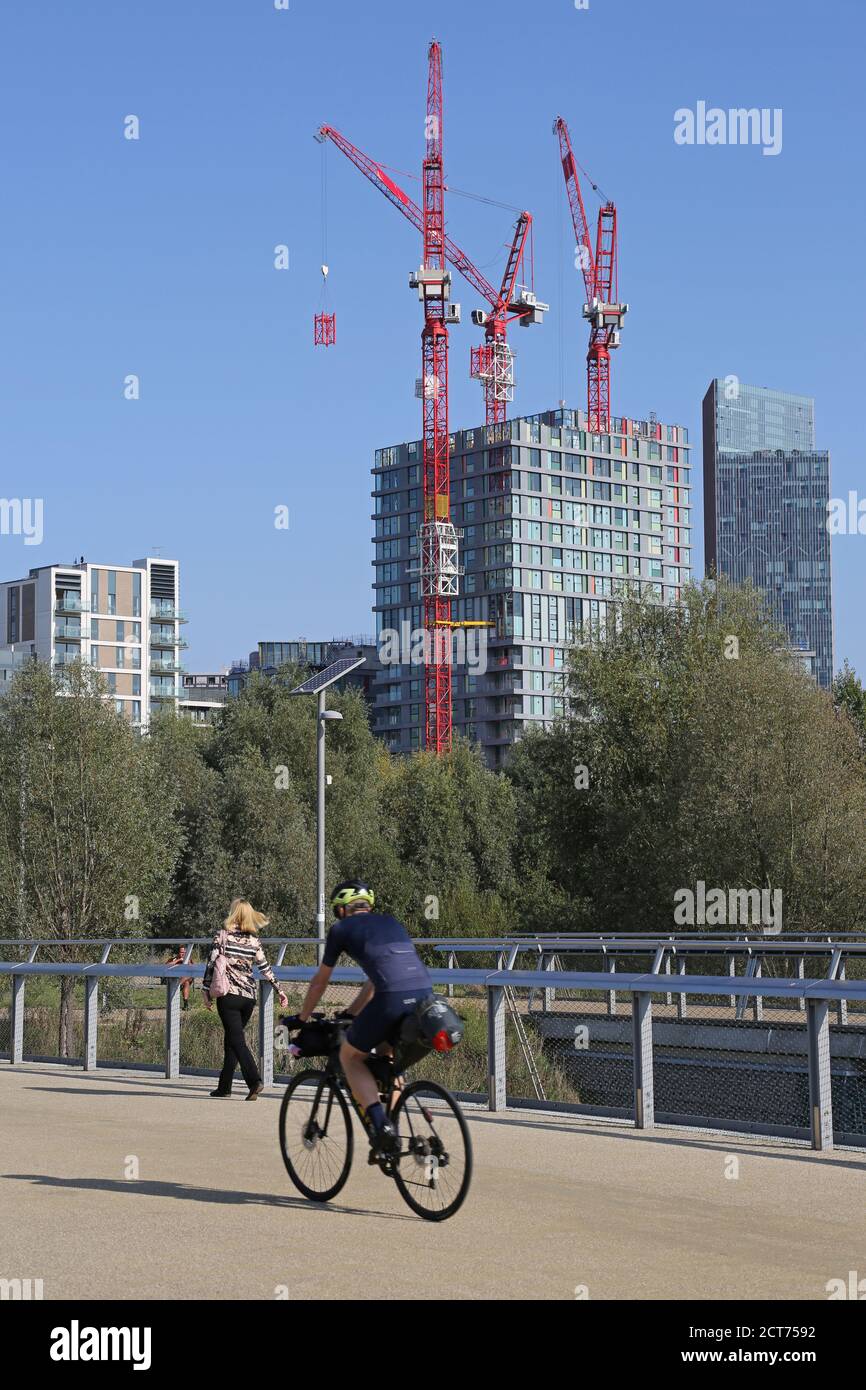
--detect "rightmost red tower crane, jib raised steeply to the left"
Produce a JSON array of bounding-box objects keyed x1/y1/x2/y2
[{"x1": 553, "y1": 115, "x2": 628, "y2": 434}]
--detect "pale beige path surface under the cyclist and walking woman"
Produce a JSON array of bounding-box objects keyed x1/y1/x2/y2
[{"x1": 0, "y1": 1065, "x2": 866, "y2": 1301}]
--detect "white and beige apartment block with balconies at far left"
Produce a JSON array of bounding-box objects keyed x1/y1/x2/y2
[{"x1": 0, "y1": 557, "x2": 186, "y2": 728}]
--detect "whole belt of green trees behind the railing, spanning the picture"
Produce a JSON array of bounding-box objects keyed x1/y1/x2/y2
[{"x1": 0, "y1": 582, "x2": 866, "y2": 967}]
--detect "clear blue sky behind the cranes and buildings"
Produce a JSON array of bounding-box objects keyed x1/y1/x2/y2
[{"x1": 0, "y1": 0, "x2": 866, "y2": 673}]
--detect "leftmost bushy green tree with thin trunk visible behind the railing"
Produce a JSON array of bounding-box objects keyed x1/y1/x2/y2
[{"x1": 0, "y1": 663, "x2": 181, "y2": 1056}]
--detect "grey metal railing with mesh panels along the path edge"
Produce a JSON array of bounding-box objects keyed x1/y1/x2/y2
[{"x1": 0, "y1": 937, "x2": 866, "y2": 1150}]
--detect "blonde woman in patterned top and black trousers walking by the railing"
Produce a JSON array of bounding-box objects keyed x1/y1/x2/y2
[{"x1": 202, "y1": 898, "x2": 289, "y2": 1101}]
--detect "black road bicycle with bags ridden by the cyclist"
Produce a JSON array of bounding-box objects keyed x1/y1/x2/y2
[{"x1": 279, "y1": 1015, "x2": 473, "y2": 1220}]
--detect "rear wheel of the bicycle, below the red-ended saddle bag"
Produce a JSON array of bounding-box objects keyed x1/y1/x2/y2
[{"x1": 391, "y1": 1081, "x2": 473, "y2": 1220}]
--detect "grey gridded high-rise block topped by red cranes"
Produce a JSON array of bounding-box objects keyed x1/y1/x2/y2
[{"x1": 373, "y1": 409, "x2": 691, "y2": 767}]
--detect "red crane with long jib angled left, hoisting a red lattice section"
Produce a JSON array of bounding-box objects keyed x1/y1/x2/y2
[{"x1": 316, "y1": 145, "x2": 549, "y2": 424}]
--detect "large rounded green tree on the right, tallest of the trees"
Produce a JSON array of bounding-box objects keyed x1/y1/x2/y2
[{"x1": 510, "y1": 581, "x2": 866, "y2": 931}]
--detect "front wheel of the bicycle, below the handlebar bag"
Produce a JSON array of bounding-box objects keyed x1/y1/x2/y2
[{"x1": 279, "y1": 1070, "x2": 354, "y2": 1202}]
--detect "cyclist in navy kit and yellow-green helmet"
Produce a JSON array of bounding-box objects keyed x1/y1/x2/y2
[{"x1": 286, "y1": 878, "x2": 432, "y2": 1151}]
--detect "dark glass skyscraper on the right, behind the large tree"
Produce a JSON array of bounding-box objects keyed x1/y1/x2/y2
[{"x1": 703, "y1": 377, "x2": 833, "y2": 687}]
